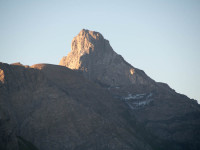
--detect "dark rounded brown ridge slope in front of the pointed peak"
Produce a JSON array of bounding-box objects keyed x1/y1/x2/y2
[{"x1": 0, "y1": 63, "x2": 153, "y2": 150}]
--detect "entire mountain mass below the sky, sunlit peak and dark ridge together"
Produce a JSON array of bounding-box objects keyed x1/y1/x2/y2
[{"x1": 0, "y1": 29, "x2": 200, "y2": 150}]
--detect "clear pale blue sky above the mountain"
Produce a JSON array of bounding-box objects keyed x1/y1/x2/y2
[{"x1": 0, "y1": 0, "x2": 200, "y2": 103}]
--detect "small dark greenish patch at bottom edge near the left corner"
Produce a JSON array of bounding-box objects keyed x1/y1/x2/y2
[{"x1": 17, "y1": 136, "x2": 38, "y2": 150}]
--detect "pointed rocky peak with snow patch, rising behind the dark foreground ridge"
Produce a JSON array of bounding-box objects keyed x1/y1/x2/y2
[{"x1": 60, "y1": 29, "x2": 200, "y2": 149}]
